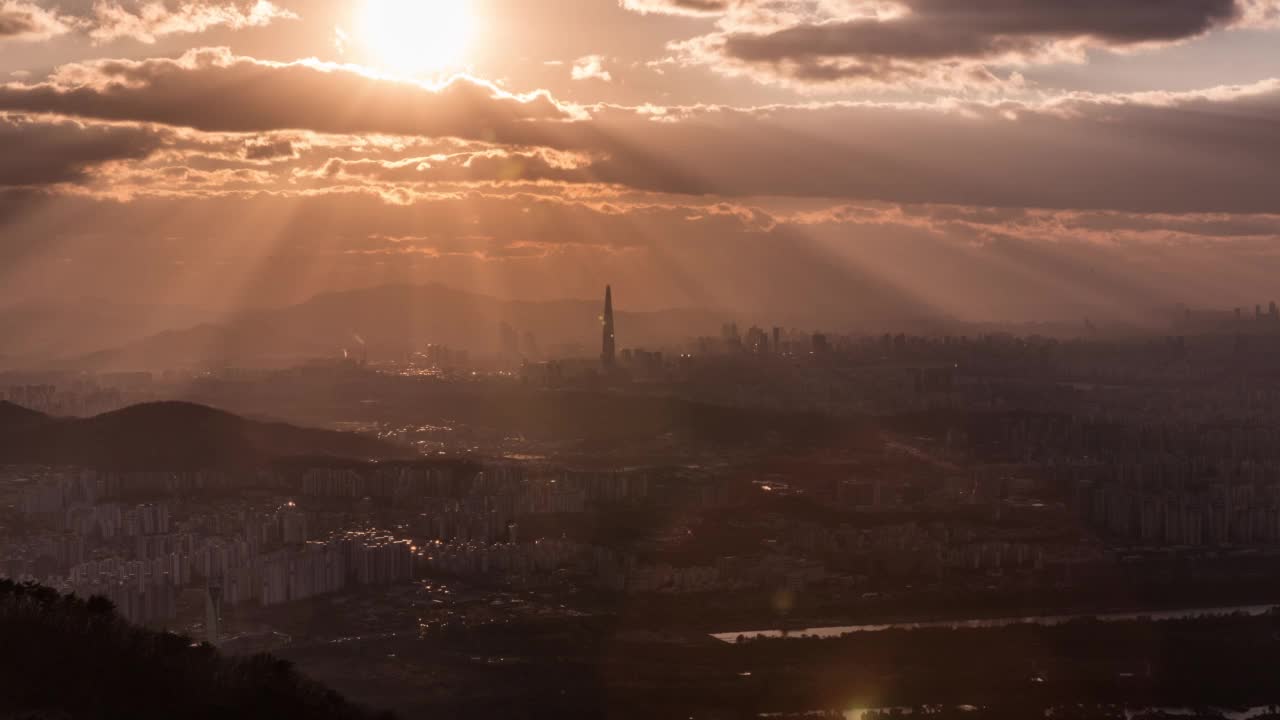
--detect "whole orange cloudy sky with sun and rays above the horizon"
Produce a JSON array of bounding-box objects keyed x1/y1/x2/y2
[{"x1": 0, "y1": 0, "x2": 1280, "y2": 323}]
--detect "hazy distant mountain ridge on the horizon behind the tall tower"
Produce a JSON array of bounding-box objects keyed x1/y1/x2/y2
[{"x1": 74, "y1": 283, "x2": 724, "y2": 369}]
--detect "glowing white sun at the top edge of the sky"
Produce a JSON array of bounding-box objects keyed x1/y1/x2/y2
[{"x1": 360, "y1": 0, "x2": 475, "y2": 74}]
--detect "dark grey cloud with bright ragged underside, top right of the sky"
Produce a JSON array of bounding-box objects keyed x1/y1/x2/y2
[{"x1": 634, "y1": 0, "x2": 1280, "y2": 90}]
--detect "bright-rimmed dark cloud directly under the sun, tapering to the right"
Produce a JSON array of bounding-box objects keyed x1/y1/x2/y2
[{"x1": 0, "y1": 49, "x2": 570, "y2": 143}]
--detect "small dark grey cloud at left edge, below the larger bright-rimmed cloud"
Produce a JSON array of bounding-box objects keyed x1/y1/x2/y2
[{"x1": 0, "y1": 115, "x2": 161, "y2": 187}]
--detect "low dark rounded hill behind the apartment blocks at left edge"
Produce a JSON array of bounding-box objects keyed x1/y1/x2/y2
[{"x1": 0, "y1": 394, "x2": 408, "y2": 470}]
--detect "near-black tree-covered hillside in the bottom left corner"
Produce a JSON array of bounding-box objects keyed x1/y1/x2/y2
[{"x1": 0, "y1": 580, "x2": 389, "y2": 720}]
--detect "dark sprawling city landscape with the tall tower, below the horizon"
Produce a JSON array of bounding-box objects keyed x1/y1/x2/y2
[{"x1": 12, "y1": 319, "x2": 1280, "y2": 720}]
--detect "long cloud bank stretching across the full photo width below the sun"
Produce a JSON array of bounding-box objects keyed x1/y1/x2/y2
[{"x1": 0, "y1": 50, "x2": 1280, "y2": 213}]
